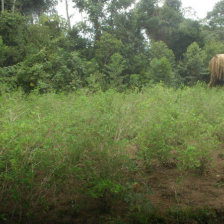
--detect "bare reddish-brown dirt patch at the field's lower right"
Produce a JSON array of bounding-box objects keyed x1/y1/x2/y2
[{"x1": 137, "y1": 150, "x2": 224, "y2": 210}]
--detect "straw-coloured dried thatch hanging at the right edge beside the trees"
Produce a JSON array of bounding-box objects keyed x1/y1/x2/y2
[{"x1": 208, "y1": 54, "x2": 224, "y2": 87}]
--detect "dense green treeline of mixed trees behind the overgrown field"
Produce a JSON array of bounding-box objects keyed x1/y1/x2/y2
[{"x1": 0, "y1": 0, "x2": 224, "y2": 93}]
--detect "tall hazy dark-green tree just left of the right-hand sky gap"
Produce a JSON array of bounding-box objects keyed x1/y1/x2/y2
[{"x1": 137, "y1": 0, "x2": 203, "y2": 60}]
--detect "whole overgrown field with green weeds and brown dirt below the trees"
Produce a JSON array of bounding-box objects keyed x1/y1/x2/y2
[{"x1": 0, "y1": 85, "x2": 224, "y2": 224}]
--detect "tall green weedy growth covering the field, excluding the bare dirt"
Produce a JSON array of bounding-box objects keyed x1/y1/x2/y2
[{"x1": 0, "y1": 85, "x2": 224, "y2": 222}]
